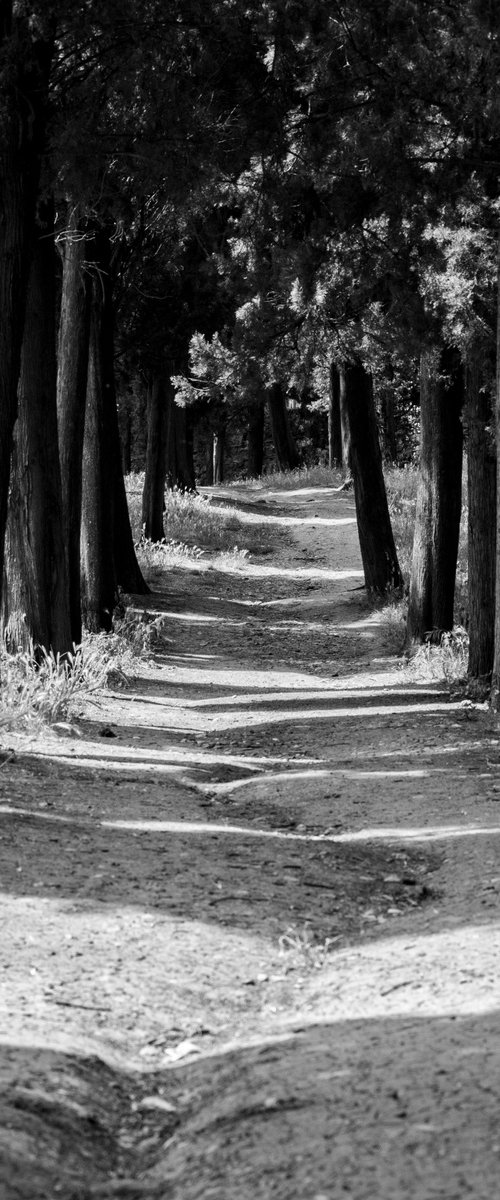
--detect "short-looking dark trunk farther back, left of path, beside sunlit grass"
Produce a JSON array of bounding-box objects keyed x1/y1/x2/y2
[{"x1": 143, "y1": 376, "x2": 168, "y2": 541}]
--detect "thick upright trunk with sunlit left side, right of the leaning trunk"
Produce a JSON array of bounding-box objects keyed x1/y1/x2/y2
[{"x1": 406, "y1": 350, "x2": 463, "y2": 643}]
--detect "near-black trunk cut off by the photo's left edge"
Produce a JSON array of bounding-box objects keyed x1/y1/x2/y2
[{"x1": 0, "y1": 18, "x2": 54, "y2": 614}]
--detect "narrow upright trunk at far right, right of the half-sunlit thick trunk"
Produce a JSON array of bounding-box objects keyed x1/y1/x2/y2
[{"x1": 465, "y1": 347, "x2": 496, "y2": 679}]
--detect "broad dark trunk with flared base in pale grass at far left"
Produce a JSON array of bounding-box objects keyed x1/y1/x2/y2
[{"x1": 6, "y1": 202, "x2": 72, "y2": 654}]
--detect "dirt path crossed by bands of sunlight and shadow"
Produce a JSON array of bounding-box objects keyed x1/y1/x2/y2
[{"x1": 0, "y1": 486, "x2": 500, "y2": 1200}]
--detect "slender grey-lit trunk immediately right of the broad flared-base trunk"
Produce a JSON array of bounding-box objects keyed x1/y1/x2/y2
[{"x1": 58, "y1": 205, "x2": 91, "y2": 646}]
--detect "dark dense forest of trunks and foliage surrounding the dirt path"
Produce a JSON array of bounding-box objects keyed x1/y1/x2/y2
[{"x1": 0, "y1": 0, "x2": 500, "y2": 704}]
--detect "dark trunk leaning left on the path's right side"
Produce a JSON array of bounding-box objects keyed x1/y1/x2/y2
[{"x1": 345, "y1": 364, "x2": 403, "y2": 595}]
